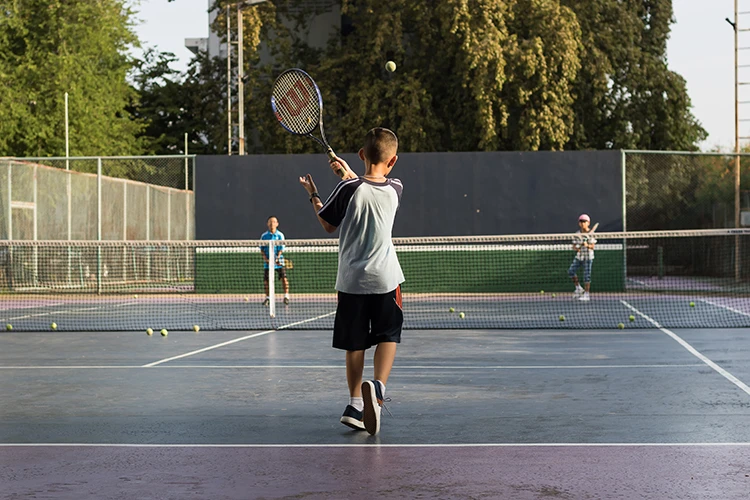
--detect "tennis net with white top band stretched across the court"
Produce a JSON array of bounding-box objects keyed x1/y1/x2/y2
[{"x1": 0, "y1": 229, "x2": 750, "y2": 331}]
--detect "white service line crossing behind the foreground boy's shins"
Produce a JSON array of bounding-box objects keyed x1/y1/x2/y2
[{"x1": 0, "y1": 363, "x2": 703, "y2": 370}]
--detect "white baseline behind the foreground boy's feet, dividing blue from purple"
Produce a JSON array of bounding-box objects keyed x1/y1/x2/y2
[{"x1": 0, "y1": 442, "x2": 750, "y2": 448}]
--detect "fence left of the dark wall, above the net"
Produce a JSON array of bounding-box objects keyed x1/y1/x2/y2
[{"x1": 0, "y1": 156, "x2": 195, "y2": 240}]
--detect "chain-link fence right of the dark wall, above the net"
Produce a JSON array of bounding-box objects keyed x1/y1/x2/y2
[{"x1": 623, "y1": 151, "x2": 750, "y2": 231}]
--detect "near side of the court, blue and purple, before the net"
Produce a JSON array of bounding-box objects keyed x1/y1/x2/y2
[{"x1": 0, "y1": 322, "x2": 750, "y2": 499}]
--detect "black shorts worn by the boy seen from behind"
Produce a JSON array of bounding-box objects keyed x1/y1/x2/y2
[{"x1": 333, "y1": 286, "x2": 404, "y2": 351}]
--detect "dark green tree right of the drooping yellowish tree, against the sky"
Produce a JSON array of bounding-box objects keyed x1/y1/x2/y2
[{"x1": 561, "y1": 0, "x2": 707, "y2": 151}]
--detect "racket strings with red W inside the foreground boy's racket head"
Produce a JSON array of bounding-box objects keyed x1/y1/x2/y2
[{"x1": 273, "y1": 72, "x2": 320, "y2": 134}]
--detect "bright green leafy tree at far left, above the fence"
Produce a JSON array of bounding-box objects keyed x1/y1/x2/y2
[{"x1": 0, "y1": 0, "x2": 142, "y2": 156}]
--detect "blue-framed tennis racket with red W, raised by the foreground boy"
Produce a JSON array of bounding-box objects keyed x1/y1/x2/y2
[{"x1": 271, "y1": 68, "x2": 344, "y2": 177}]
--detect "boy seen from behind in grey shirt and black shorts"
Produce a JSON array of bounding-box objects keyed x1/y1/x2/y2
[{"x1": 299, "y1": 127, "x2": 404, "y2": 435}]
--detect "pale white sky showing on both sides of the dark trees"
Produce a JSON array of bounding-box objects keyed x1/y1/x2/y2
[{"x1": 136, "y1": 0, "x2": 736, "y2": 151}]
